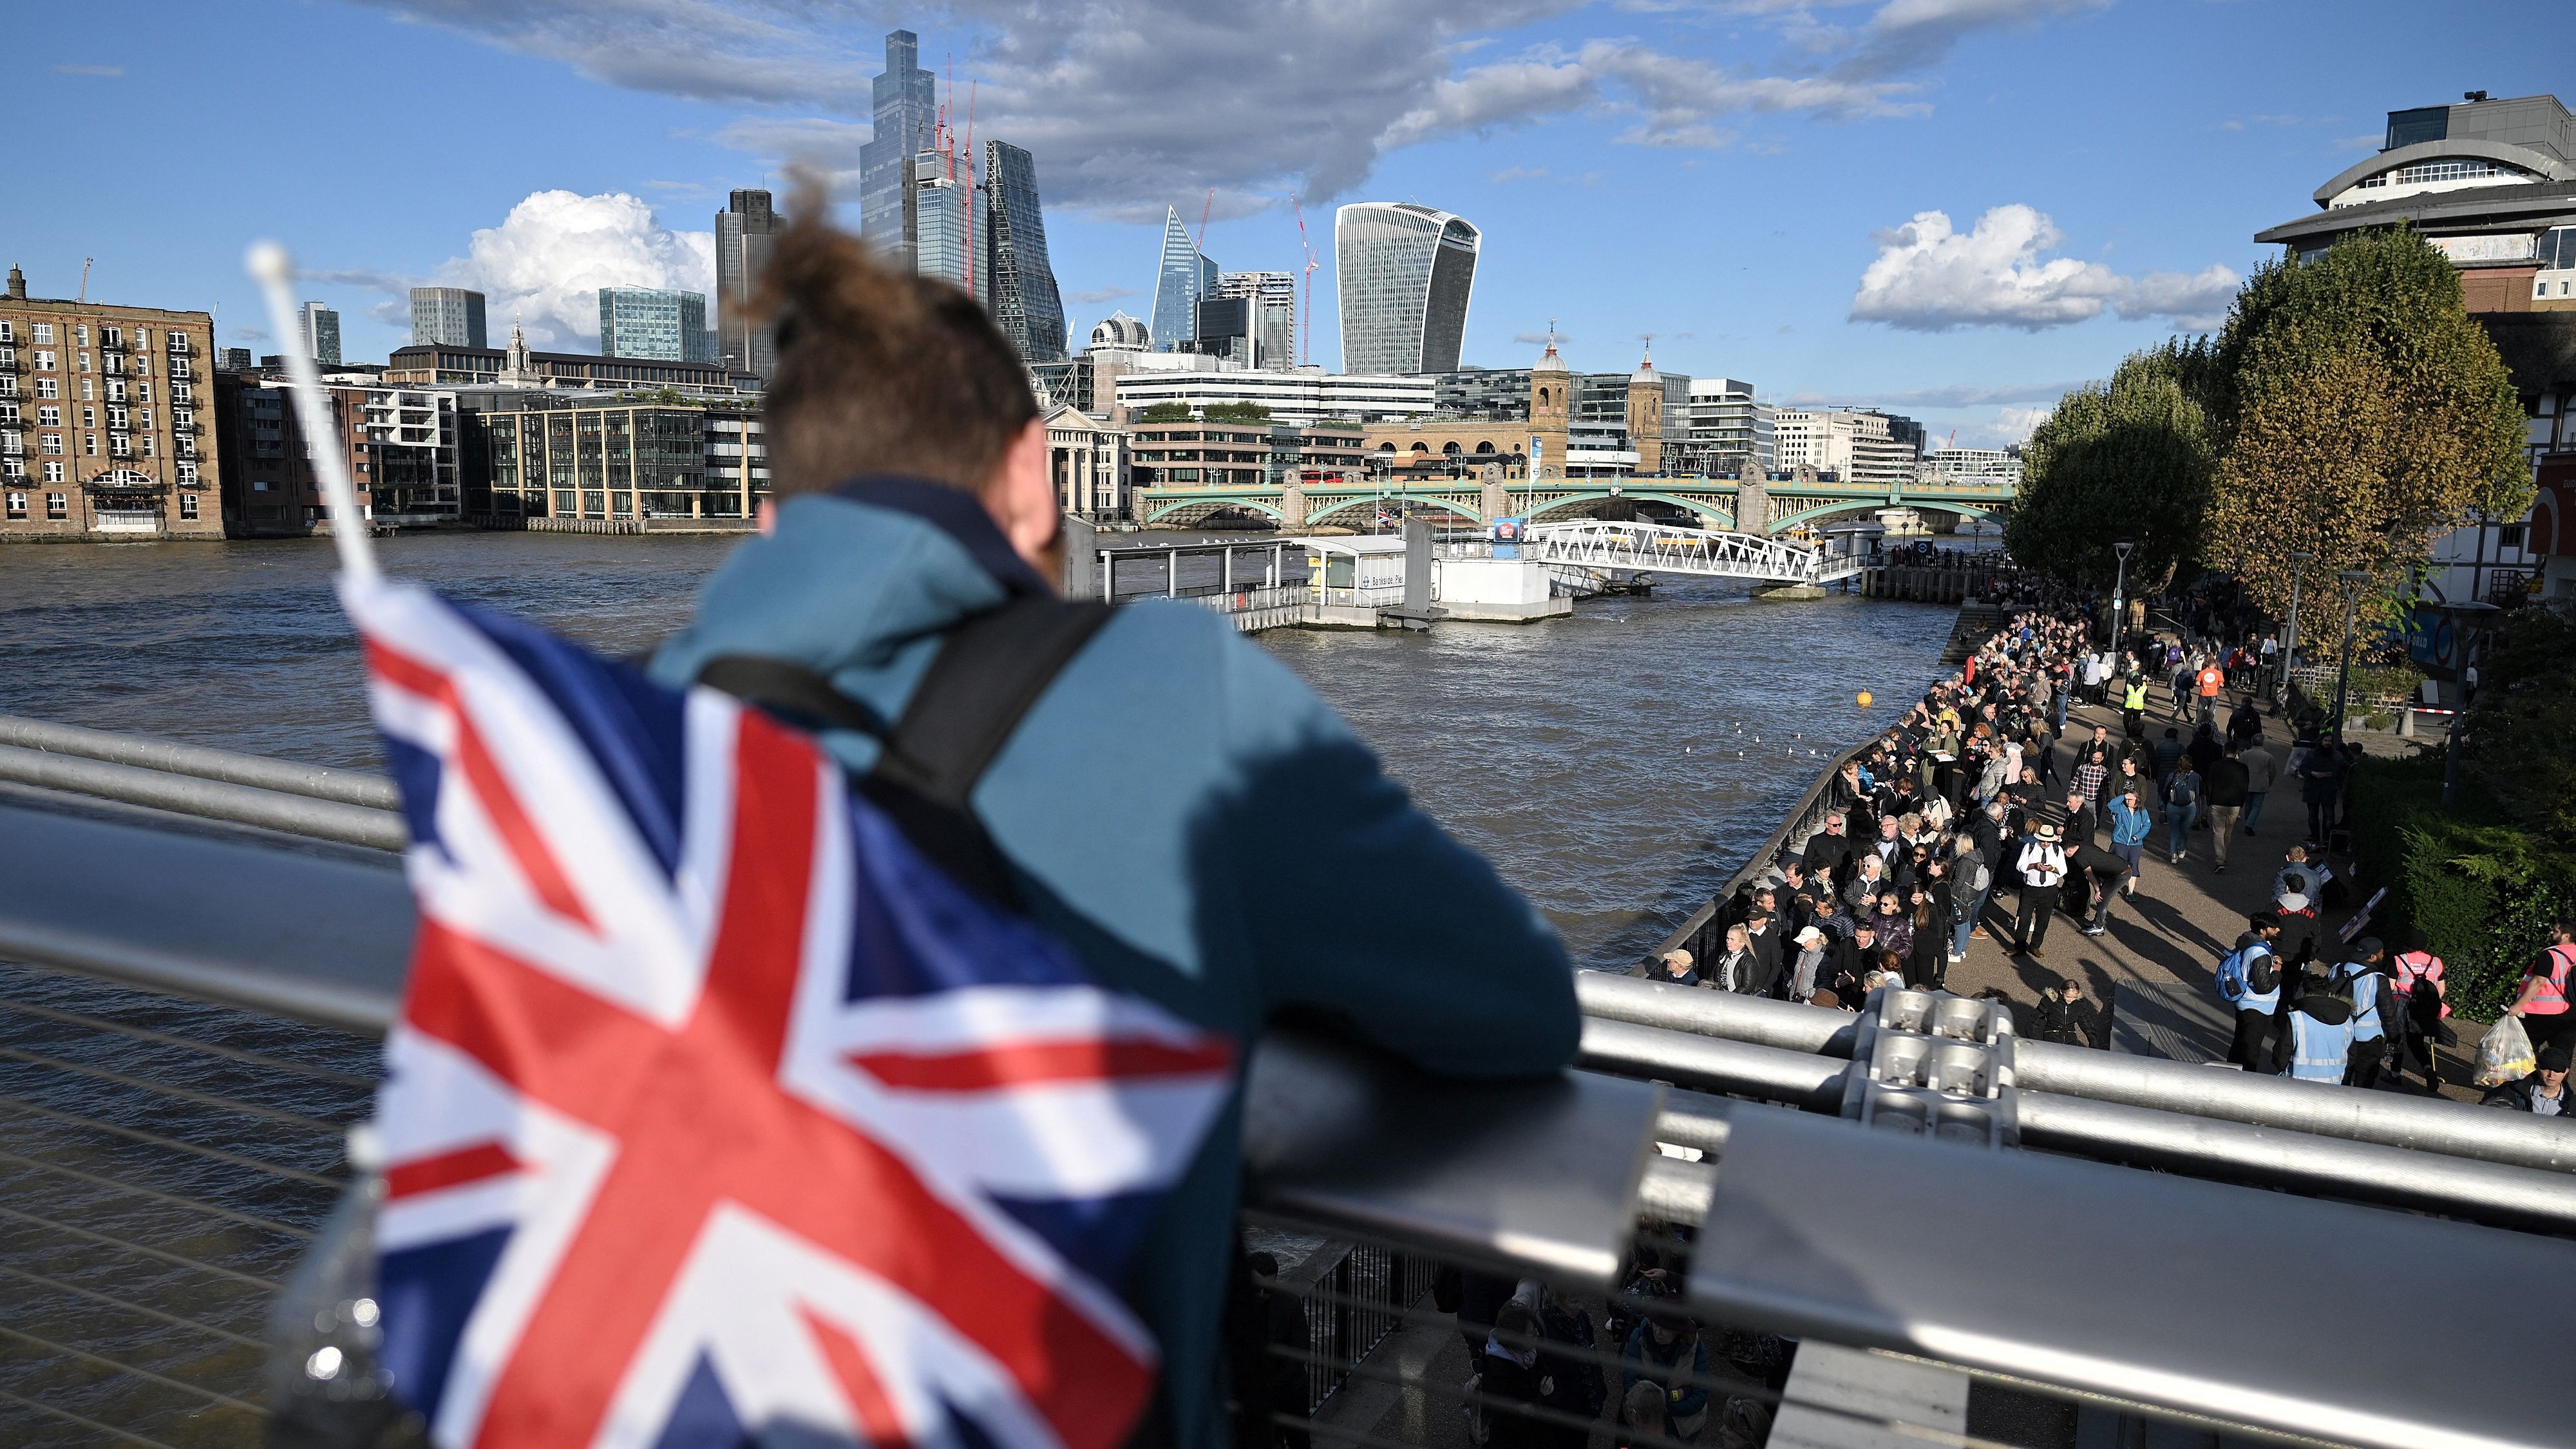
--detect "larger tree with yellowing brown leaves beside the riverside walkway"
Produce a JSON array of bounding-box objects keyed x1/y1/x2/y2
[{"x1": 2202, "y1": 229, "x2": 2532, "y2": 621}]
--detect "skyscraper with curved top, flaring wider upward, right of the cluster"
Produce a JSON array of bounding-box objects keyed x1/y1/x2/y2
[{"x1": 1332, "y1": 201, "x2": 1484, "y2": 374}]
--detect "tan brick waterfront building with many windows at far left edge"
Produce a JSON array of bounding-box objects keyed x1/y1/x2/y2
[{"x1": 0, "y1": 268, "x2": 224, "y2": 542}]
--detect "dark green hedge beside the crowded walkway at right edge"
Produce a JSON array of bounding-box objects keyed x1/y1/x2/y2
[{"x1": 2352, "y1": 753, "x2": 2576, "y2": 1021}]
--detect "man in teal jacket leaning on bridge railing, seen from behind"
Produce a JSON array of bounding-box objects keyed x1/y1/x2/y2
[{"x1": 652, "y1": 191, "x2": 1579, "y2": 1449}]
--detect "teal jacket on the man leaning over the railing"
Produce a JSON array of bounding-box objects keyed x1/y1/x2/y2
[{"x1": 652, "y1": 482, "x2": 1579, "y2": 1449}]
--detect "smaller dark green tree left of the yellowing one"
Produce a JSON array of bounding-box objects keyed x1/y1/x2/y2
[{"x1": 2004, "y1": 340, "x2": 2213, "y2": 593}]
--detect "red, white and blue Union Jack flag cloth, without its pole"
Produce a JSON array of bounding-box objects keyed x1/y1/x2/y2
[{"x1": 343, "y1": 583, "x2": 1234, "y2": 1449}]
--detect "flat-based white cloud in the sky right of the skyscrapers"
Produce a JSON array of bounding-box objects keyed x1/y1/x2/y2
[{"x1": 1852, "y1": 204, "x2": 2239, "y2": 332}]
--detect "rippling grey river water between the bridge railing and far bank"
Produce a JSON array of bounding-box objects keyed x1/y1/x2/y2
[{"x1": 0, "y1": 534, "x2": 1953, "y2": 967}]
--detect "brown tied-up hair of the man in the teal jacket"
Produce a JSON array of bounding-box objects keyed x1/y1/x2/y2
[{"x1": 752, "y1": 175, "x2": 1038, "y2": 498}]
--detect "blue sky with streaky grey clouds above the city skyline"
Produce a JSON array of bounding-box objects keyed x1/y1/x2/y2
[{"x1": 0, "y1": 0, "x2": 2576, "y2": 446}]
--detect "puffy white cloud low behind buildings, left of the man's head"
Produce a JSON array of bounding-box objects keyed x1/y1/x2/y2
[{"x1": 438, "y1": 191, "x2": 716, "y2": 350}]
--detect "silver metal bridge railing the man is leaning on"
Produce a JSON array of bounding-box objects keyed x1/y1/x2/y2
[{"x1": 0, "y1": 748, "x2": 2576, "y2": 1449}]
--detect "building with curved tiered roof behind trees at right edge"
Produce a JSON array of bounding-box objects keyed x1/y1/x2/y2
[{"x1": 2254, "y1": 90, "x2": 2576, "y2": 603}]
